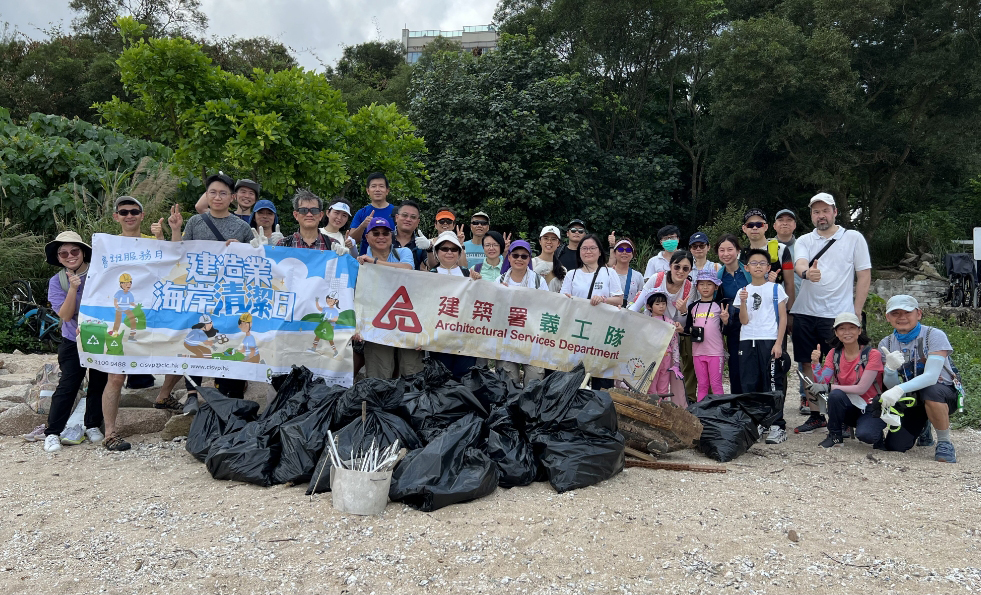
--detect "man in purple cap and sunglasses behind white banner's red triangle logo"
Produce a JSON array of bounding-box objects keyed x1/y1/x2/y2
[{"x1": 352, "y1": 217, "x2": 423, "y2": 378}]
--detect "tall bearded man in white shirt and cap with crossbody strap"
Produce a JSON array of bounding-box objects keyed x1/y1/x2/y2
[{"x1": 791, "y1": 192, "x2": 872, "y2": 433}]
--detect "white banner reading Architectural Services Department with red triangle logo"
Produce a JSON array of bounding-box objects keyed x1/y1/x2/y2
[{"x1": 354, "y1": 265, "x2": 674, "y2": 385}]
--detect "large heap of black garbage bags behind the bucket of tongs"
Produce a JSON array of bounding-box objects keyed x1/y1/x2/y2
[{"x1": 187, "y1": 359, "x2": 624, "y2": 511}]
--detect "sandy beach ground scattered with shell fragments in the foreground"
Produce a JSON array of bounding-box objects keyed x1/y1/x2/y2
[{"x1": 0, "y1": 370, "x2": 981, "y2": 594}]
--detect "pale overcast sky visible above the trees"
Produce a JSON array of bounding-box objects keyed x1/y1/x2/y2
[{"x1": 0, "y1": 0, "x2": 497, "y2": 70}]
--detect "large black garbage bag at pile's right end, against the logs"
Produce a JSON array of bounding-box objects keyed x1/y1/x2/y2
[{"x1": 516, "y1": 364, "x2": 624, "y2": 493}]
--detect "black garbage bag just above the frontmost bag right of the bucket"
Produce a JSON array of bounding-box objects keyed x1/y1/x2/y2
[{"x1": 398, "y1": 380, "x2": 488, "y2": 443}]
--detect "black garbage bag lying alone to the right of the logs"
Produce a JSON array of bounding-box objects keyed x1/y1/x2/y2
[{"x1": 688, "y1": 392, "x2": 784, "y2": 463}]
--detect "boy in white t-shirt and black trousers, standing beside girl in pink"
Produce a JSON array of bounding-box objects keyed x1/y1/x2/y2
[{"x1": 732, "y1": 248, "x2": 787, "y2": 444}]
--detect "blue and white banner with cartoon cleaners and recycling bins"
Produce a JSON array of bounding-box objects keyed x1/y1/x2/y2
[{"x1": 78, "y1": 234, "x2": 358, "y2": 386}]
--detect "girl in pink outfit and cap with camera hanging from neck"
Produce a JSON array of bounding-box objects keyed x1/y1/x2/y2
[{"x1": 688, "y1": 270, "x2": 729, "y2": 401}]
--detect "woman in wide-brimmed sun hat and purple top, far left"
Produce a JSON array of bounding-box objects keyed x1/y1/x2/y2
[{"x1": 44, "y1": 231, "x2": 108, "y2": 452}]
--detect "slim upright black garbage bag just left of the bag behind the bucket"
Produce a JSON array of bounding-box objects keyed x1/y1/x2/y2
[{"x1": 272, "y1": 384, "x2": 346, "y2": 484}]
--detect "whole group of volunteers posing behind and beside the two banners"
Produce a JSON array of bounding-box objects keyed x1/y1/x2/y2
[{"x1": 30, "y1": 172, "x2": 961, "y2": 463}]
